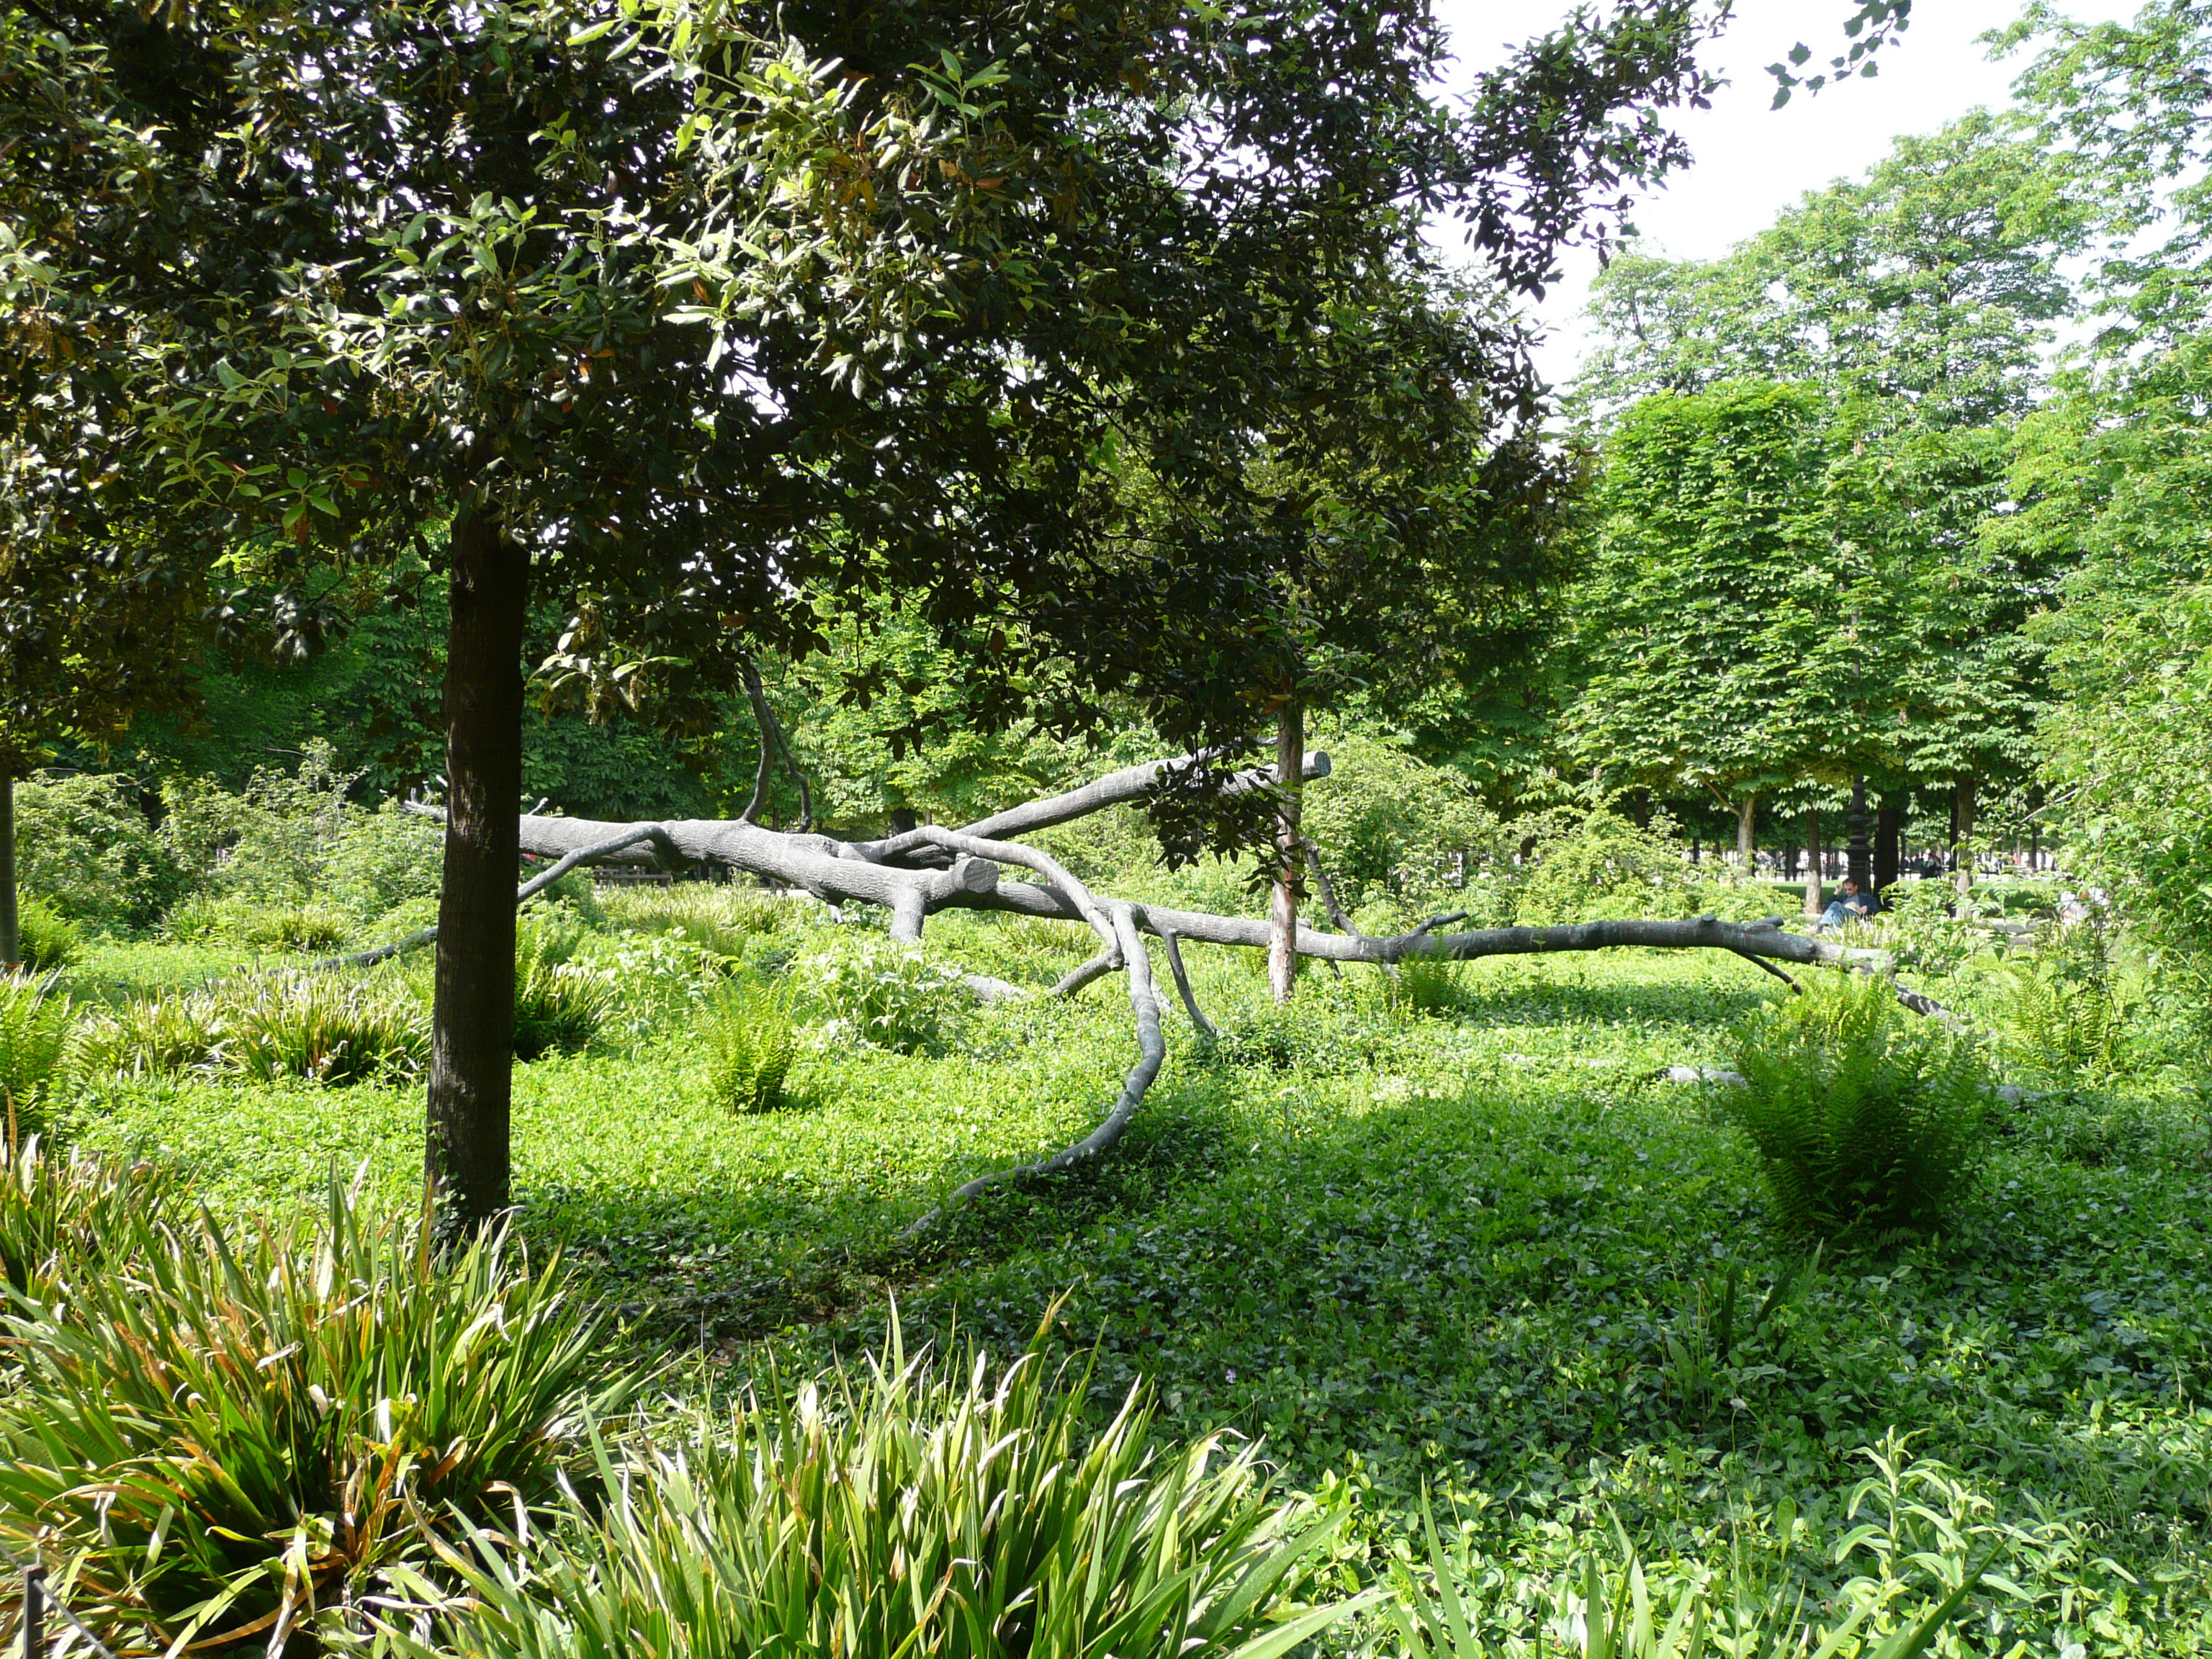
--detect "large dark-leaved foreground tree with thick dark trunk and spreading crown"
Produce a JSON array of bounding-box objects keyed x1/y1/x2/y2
[{"x1": 0, "y1": 0, "x2": 1710, "y2": 1223}]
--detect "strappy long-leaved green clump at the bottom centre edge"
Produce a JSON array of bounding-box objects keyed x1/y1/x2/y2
[{"x1": 398, "y1": 1354, "x2": 1343, "y2": 1659}]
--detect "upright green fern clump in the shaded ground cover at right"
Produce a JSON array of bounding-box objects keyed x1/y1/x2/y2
[{"x1": 1721, "y1": 974, "x2": 1989, "y2": 1246}]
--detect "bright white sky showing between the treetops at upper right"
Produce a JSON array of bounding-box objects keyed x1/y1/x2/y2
[{"x1": 1436, "y1": 0, "x2": 2139, "y2": 380}]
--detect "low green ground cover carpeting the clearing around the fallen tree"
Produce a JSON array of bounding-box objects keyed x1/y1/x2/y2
[{"x1": 35, "y1": 918, "x2": 2212, "y2": 1657}]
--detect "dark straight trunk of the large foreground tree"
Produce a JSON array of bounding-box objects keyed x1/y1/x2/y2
[{"x1": 425, "y1": 506, "x2": 531, "y2": 1236}]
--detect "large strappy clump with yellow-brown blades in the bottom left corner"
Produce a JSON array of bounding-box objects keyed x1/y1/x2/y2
[{"x1": 0, "y1": 1197, "x2": 639, "y2": 1653}]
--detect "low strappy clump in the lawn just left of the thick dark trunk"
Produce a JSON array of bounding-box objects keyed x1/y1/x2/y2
[{"x1": 219, "y1": 974, "x2": 429, "y2": 1086}]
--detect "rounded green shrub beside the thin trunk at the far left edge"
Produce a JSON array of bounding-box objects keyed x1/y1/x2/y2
[{"x1": 16, "y1": 772, "x2": 190, "y2": 927}]
